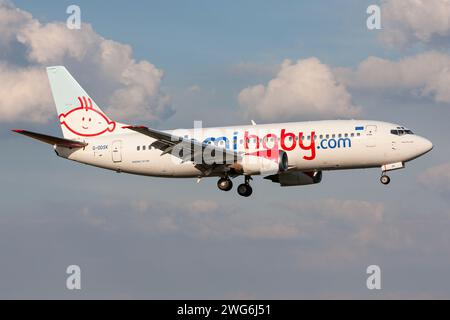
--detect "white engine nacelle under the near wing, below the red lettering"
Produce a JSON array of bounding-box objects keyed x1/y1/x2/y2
[{"x1": 235, "y1": 150, "x2": 289, "y2": 175}]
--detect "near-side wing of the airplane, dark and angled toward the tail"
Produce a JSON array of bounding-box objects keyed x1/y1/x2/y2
[{"x1": 124, "y1": 126, "x2": 242, "y2": 172}]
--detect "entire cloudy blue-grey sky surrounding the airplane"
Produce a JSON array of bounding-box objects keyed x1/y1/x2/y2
[{"x1": 0, "y1": 0, "x2": 450, "y2": 299}]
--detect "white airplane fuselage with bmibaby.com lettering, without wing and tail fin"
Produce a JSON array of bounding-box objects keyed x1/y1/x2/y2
[{"x1": 55, "y1": 120, "x2": 432, "y2": 177}]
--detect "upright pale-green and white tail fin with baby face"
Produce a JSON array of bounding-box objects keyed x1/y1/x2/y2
[{"x1": 47, "y1": 67, "x2": 118, "y2": 139}]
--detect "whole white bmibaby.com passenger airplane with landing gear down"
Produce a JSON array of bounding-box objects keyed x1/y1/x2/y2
[{"x1": 13, "y1": 66, "x2": 433, "y2": 197}]
